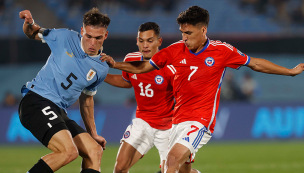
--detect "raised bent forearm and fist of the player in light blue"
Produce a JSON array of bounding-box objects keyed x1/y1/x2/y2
[{"x1": 19, "y1": 10, "x2": 45, "y2": 40}]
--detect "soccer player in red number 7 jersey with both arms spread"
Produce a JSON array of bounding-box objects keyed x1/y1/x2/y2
[{"x1": 101, "y1": 6, "x2": 304, "y2": 173}]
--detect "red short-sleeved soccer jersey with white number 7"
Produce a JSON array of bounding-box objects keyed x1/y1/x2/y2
[{"x1": 150, "y1": 39, "x2": 250, "y2": 132}]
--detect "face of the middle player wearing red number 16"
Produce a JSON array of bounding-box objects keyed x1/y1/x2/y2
[{"x1": 137, "y1": 30, "x2": 162, "y2": 58}]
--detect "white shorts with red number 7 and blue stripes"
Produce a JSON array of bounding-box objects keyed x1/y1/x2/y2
[{"x1": 169, "y1": 121, "x2": 211, "y2": 163}]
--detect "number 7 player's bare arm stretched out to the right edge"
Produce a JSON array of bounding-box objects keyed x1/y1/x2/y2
[{"x1": 248, "y1": 57, "x2": 304, "y2": 76}]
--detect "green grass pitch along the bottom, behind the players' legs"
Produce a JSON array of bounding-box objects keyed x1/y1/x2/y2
[{"x1": 0, "y1": 141, "x2": 304, "y2": 173}]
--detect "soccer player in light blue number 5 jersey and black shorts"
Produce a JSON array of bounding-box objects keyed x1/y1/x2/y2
[{"x1": 19, "y1": 8, "x2": 110, "y2": 173}]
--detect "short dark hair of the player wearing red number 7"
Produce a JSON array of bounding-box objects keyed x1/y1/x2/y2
[{"x1": 176, "y1": 6, "x2": 209, "y2": 27}]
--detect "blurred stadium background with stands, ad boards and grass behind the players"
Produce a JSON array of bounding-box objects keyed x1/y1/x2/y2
[{"x1": 0, "y1": 0, "x2": 304, "y2": 173}]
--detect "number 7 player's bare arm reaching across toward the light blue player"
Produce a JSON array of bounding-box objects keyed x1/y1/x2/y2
[{"x1": 100, "y1": 54, "x2": 155, "y2": 74}]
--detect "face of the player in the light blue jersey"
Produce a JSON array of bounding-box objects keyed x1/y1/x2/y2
[{"x1": 81, "y1": 25, "x2": 108, "y2": 56}]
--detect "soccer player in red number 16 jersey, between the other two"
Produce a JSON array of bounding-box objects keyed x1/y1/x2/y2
[{"x1": 105, "y1": 22, "x2": 202, "y2": 173}]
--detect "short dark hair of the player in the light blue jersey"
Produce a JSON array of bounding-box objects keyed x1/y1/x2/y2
[{"x1": 83, "y1": 7, "x2": 111, "y2": 28}]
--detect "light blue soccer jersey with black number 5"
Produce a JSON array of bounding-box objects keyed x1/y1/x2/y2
[{"x1": 23, "y1": 29, "x2": 109, "y2": 109}]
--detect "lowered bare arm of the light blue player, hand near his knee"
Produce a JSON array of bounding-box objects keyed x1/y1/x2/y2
[{"x1": 79, "y1": 93, "x2": 107, "y2": 149}]
